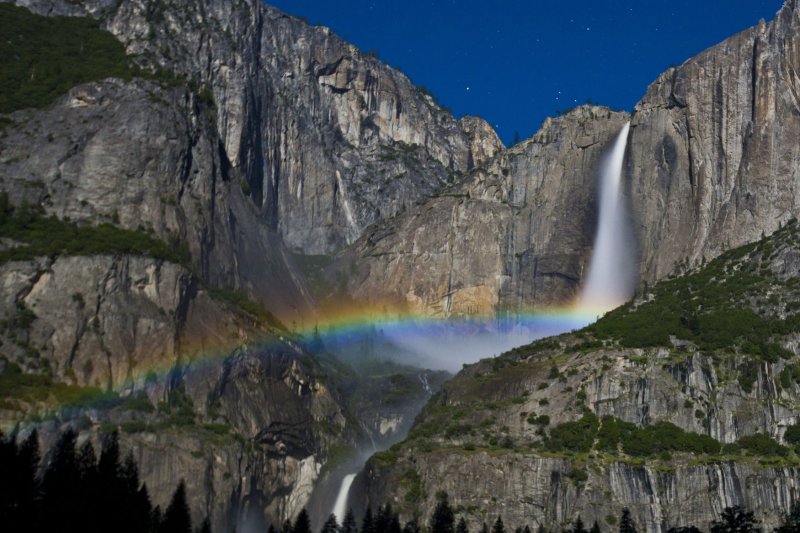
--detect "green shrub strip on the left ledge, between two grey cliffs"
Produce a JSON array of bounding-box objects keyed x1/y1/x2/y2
[{"x1": 0, "y1": 197, "x2": 190, "y2": 265}]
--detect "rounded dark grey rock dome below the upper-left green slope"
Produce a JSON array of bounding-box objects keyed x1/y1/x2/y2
[{"x1": 0, "y1": 76, "x2": 313, "y2": 321}]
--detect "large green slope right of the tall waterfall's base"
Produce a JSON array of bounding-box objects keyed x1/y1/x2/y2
[{"x1": 587, "y1": 221, "x2": 800, "y2": 360}]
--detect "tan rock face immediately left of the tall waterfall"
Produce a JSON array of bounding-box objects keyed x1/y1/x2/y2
[{"x1": 342, "y1": 107, "x2": 628, "y2": 316}]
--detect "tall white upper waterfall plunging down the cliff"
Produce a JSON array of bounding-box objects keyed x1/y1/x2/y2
[{"x1": 579, "y1": 123, "x2": 634, "y2": 312}]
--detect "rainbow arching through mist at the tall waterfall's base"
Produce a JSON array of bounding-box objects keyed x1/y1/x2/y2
[{"x1": 0, "y1": 305, "x2": 607, "y2": 420}]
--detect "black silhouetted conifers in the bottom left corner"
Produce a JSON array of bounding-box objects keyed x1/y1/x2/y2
[{"x1": 0, "y1": 429, "x2": 211, "y2": 533}]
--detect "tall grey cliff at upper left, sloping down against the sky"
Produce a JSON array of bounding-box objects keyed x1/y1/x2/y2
[{"x1": 20, "y1": 0, "x2": 469, "y2": 254}]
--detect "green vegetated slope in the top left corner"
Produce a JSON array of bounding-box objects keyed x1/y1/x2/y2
[{"x1": 0, "y1": 4, "x2": 138, "y2": 113}]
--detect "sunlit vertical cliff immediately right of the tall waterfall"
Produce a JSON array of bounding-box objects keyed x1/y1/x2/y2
[{"x1": 625, "y1": 0, "x2": 800, "y2": 281}]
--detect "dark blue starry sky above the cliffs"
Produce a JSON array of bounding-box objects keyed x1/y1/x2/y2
[{"x1": 268, "y1": 0, "x2": 783, "y2": 144}]
